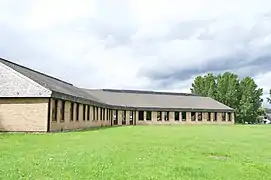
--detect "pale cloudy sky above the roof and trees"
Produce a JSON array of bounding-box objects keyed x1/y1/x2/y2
[{"x1": 0, "y1": 0, "x2": 271, "y2": 105}]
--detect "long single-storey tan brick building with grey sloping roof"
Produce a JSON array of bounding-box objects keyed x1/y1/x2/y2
[{"x1": 0, "y1": 59, "x2": 235, "y2": 132}]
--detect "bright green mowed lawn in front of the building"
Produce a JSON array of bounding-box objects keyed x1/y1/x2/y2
[{"x1": 0, "y1": 125, "x2": 271, "y2": 180}]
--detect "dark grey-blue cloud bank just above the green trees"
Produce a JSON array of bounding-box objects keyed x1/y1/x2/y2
[{"x1": 141, "y1": 51, "x2": 271, "y2": 86}]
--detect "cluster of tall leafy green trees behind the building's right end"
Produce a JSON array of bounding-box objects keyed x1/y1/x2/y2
[{"x1": 190, "y1": 72, "x2": 271, "y2": 123}]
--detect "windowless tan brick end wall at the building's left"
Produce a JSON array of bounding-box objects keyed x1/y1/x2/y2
[{"x1": 0, "y1": 98, "x2": 49, "y2": 132}]
